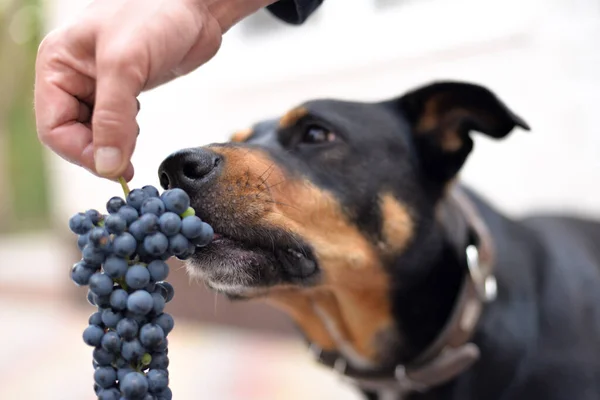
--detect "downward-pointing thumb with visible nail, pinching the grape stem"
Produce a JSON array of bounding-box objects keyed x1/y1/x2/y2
[{"x1": 92, "y1": 58, "x2": 145, "y2": 178}]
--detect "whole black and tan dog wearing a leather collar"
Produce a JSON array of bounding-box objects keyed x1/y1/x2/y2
[{"x1": 159, "y1": 82, "x2": 600, "y2": 400}]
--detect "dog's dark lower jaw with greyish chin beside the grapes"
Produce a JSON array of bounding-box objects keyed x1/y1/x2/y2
[{"x1": 187, "y1": 234, "x2": 319, "y2": 299}]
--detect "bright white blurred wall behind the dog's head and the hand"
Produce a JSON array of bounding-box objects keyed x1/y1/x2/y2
[{"x1": 43, "y1": 0, "x2": 600, "y2": 223}]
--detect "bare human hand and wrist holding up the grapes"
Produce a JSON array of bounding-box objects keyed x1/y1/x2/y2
[{"x1": 35, "y1": 0, "x2": 275, "y2": 180}]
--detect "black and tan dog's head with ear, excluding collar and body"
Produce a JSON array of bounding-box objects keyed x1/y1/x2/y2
[{"x1": 159, "y1": 82, "x2": 528, "y2": 363}]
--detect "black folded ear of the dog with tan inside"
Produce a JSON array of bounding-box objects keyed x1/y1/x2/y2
[{"x1": 394, "y1": 82, "x2": 529, "y2": 183}]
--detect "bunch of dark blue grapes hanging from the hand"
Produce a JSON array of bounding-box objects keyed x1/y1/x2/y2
[{"x1": 69, "y1": 180, "x2": 213, "y2": 400}]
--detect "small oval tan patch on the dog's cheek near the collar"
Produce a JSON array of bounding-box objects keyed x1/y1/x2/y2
[{"x1": 380, "y1": 193, "x2": 414, "y2": 254}]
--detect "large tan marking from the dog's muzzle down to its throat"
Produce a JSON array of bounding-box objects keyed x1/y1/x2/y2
[{"x1": 206, "y1": 147, "x2": 401, "y2": 359}]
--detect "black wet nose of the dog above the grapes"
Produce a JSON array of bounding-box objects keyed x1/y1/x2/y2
[{"x1": 158, "y1": 148, "x2": 222, "y2": 190}]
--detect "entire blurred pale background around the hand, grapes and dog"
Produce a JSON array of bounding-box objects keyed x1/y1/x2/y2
[{"x1": 0, "y1": 0, "x2": 600, "y2": 400}]
